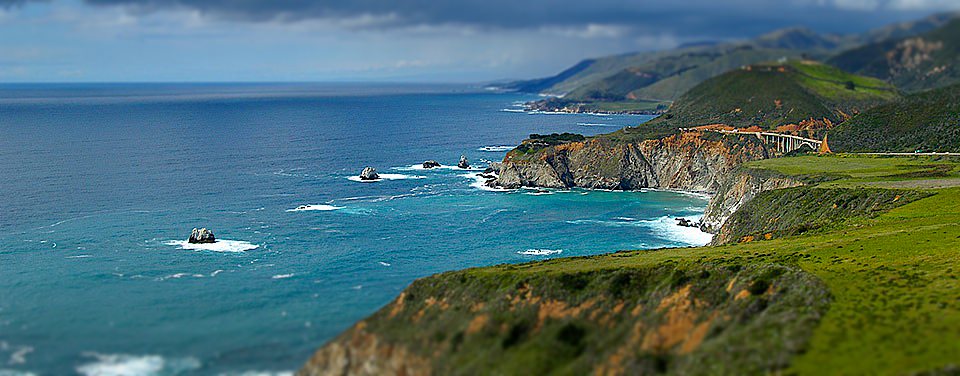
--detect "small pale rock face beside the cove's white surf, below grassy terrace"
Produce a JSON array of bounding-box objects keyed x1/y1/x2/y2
[{"x1": 700, "y1": 170, "x2": 803, "y2": 236}]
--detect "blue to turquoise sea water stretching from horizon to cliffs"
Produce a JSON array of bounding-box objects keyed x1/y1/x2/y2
[{"x1": 0, "y1": 84, "x2": 709, "y2": 375}]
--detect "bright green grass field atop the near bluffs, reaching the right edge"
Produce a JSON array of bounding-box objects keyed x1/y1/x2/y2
[{"x1": 492, "y1": 155, "x2": 960, "y2": 375}]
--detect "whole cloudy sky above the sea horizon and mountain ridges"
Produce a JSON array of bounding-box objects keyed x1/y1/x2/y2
[{"x1": 0, "y1": 0, "x2": 960, "y2": 82}]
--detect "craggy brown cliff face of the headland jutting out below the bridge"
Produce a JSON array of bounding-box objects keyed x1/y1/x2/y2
[{"x1": 495, "y1": 132, "x2": 775, "y2": 193}]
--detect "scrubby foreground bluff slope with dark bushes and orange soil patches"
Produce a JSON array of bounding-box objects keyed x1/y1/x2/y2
[{"x1": 299, "y1": 251, "x2": 829, "y2": 376}]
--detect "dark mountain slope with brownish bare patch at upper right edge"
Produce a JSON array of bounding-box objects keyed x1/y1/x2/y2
[{"x1": 829, "y1": 18, "x2": 960, "y2": 92}]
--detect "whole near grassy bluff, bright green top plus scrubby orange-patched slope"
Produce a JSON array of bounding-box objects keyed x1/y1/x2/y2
[{"x1": 303, "y1": 156, "x2": 960, "y2": 375}]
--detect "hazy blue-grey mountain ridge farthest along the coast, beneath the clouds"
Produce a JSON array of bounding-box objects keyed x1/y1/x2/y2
[{"x1": 504, "y1": 13, "x2": 956, "y2": 111}]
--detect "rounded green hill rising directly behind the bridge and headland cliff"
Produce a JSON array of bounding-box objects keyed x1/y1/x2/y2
[{"x1": 609, "y1": 61, "x2": 899, "y2": 140}]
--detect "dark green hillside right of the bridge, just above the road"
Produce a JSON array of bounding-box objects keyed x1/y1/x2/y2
[{"x1": 829, "y1": 85, "x2": 960, "y2": 153}]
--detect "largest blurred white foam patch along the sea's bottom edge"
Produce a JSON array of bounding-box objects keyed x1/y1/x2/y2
[{"x1": 76, "y1": 353, "x2": 200, "y2": 376}]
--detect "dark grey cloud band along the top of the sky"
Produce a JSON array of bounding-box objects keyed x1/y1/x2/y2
[{"x1": 0, "y1": 0, "x2": 956, "y2": 38}]
